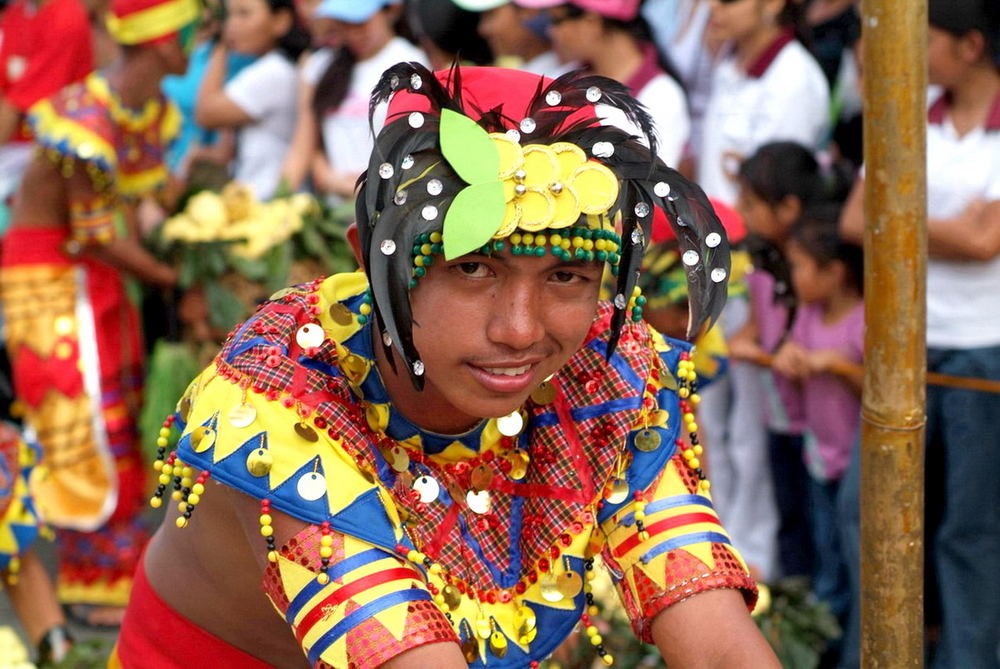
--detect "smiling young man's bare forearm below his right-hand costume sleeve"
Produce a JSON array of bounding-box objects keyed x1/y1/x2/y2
[{"x1": 652, "y1": 590, "x2": 781, "y2": 669}]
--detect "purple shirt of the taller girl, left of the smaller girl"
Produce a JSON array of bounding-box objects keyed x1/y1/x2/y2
[{"x1": 746, "y1": 269, "x2": 804, "y2": 434}]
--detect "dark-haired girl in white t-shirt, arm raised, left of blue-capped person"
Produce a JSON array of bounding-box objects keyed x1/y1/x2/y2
[{"x1": 195, "y1": 0, "x2": 309, "y2": 199}]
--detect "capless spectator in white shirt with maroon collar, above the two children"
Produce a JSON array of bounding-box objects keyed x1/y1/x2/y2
[{"x1": 697, "y1": 0, "x2": 830, "y2": 204}]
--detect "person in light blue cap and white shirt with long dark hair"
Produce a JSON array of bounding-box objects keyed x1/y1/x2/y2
[{"x1": 282, "y1": 0, "x2": 426, "y2": 198}]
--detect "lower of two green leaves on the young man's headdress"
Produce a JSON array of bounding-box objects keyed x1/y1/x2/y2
[{"x1": 441, "y1": 181, "x2": 507, "y2": 260}]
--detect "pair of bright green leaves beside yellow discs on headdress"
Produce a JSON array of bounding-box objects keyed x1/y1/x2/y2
[{"x1": 439, "y1": 109, "x2": 506, "y2": 260}]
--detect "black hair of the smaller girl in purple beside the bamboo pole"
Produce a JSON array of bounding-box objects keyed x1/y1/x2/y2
[{"x1": 790, "y1": 202, "x2": 865, "y2": 295}]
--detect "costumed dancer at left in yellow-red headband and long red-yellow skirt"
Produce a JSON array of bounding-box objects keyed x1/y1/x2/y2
[{"x1": 0, "y1": 0, "x2": 199, "y2": 623}]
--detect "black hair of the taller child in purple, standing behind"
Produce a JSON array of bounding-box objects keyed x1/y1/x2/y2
[{"x1": 739, "y1": 142, "x2": 825, "y2": 206}]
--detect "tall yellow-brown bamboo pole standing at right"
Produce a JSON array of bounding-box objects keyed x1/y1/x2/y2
[{"x1": 861, "y1": 0, "x2": 927, "y2": 669}]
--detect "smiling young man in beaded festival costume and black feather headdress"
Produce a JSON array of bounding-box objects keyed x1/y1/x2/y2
[{"x1": 121, "y1": 64, "x2": 778, "y2": 668}]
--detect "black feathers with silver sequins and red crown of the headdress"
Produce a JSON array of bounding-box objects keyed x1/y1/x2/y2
[{"x1": 356, "y1": 63, "x2": 730, "y2": 388}]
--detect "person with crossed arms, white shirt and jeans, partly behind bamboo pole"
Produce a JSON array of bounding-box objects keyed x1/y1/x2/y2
[{"x1": 841, "y1": 0, "x2": 1000, "y2": 669}]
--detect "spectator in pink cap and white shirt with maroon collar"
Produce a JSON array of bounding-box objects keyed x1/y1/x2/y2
[{"x1": 515, "y1": 0, "x2": 691, "y2": 167}]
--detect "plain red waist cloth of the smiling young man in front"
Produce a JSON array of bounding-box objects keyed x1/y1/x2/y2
[{"x1": 108, "y1": 560, "x2": 272, "y2": 669}]
